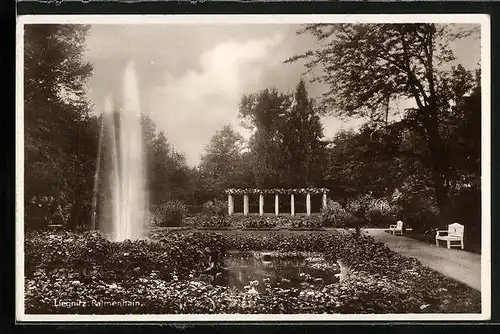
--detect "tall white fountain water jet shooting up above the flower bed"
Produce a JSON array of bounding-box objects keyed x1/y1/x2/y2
[{"x1": 99, "y1": 62, "x2": 147, "y2": 241}]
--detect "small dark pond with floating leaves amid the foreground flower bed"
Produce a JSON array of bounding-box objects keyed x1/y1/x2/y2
[{"x1": 203, "y1": 251, "x2": 340, "y2": 292}]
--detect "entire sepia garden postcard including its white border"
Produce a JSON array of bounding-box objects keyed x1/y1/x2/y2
[{"x1": 16, "y1": 14, "x2": 491, "y2": 321}]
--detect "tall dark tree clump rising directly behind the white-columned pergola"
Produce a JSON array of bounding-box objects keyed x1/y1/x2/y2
[{"x1": 240, "y1": 80, "x2": 323, "y2": 187}]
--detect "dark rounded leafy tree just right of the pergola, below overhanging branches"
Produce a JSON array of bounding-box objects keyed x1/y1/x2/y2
[{"x1": 324, "y1": 122, "x2": 430, "y2": 198}]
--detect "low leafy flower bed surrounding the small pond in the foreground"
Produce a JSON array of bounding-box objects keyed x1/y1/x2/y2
[{"x1": 25, "y1": 231, "x2": 481, "y2": 314}]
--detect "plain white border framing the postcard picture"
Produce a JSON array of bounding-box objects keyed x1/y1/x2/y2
[{"x1": 15, "y1": 14, "x2": 491, "y2": 322}]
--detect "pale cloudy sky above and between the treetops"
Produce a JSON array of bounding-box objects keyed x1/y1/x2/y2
[{"x1": 86, "y1": 24, "x2": 480, "y2": 165}]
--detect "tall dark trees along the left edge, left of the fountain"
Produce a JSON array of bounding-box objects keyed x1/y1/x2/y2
[{"x1": 24, "y1": 24, "x2": 94, "y2": 224}]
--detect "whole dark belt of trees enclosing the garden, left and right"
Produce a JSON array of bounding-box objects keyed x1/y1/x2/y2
[{"x1": 24, "y1": 24, "x2": 481, "y2": 235}]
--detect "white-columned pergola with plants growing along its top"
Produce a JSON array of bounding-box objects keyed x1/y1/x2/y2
[{"x1": 226, "y1": 188, "x2": 330, "y2": 216}]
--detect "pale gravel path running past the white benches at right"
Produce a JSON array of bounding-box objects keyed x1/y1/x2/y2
[{"x1": 363, "y1": 229, "x2": 481, "y2": 291}]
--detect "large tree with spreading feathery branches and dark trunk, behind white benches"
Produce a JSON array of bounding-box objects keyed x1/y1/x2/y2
[{"x1": 288, "y1": 24, "x2": 476, "y2": 217}]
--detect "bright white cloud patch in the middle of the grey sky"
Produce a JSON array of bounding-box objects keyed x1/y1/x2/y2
[{"x1": 150, "y1": 34, "x2": 282, "y2": 165}]
